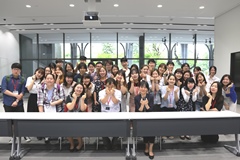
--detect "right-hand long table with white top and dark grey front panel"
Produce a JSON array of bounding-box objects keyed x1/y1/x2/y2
[{"x1": 131, "y1": 111, "x2": 240, "y2": 156}]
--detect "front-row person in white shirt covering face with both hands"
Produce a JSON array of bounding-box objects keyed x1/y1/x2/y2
[{"x1": 99, "y1": 78, "x2": 122, "y2": 150}]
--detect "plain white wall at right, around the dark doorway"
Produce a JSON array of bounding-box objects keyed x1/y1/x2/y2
[{"x1": 214, "y1": 6, "x2": 240, "y2": 78}]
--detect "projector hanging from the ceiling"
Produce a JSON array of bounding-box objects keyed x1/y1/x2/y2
[{"x1": 82, "y1": 11, "x2": 101, "y2": 28}]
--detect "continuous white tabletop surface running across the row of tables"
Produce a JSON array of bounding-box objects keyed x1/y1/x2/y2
[{"x1": 0, "y1": 111, "x2": 240, "y2": 120}]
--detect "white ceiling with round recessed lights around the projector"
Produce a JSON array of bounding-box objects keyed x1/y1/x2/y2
[{"x1": 0, "y1": 0, "x2": 240, "y2": 34}]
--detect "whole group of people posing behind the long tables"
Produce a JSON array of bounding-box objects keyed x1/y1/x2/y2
[{"x1": 2, "y1": 56, "x2": 237, "y2": 159}]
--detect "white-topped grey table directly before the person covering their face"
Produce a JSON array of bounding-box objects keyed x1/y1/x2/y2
[{"x1": 0, "y1": 113, "x2": 130, "y2": 160}]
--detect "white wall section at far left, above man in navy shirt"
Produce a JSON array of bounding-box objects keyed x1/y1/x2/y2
[{"x1": 0, "y1": 27, "x2": 19, "y2": 82}]
